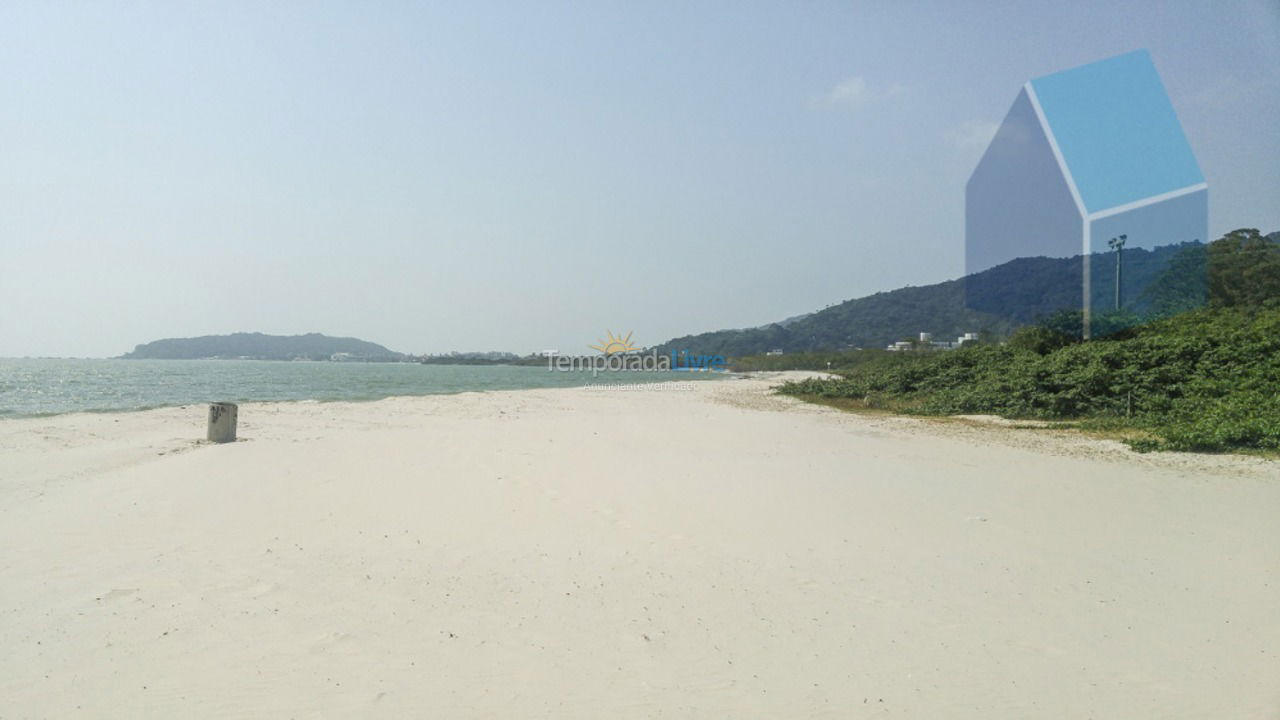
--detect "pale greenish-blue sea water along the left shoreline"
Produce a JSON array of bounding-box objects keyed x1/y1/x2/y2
[{"x1": 0, "y1": 359, "x2": 723, "y2": 418}]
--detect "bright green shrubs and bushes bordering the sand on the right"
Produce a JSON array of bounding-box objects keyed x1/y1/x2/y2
[{"x1": 780, "y1": 231, "x2": 1280, "y2": 451}]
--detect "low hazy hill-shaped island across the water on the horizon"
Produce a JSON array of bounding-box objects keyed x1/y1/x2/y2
[{"x1": 120, "y1": 333, "x2": 408, "y2": 363}]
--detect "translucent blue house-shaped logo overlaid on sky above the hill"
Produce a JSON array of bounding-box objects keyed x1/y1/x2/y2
[{"x1": 965, "y1": 50, "x2": 1208, "y2": 331}]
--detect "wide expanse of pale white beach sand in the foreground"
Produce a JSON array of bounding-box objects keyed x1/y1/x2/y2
[{"x1": 0, "y1": 371, "x2": 1280, "y2": 719}]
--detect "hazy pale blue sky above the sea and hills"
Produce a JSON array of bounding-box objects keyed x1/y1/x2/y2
[{"x1": 0, "y1": 0, "x2": 1280, "y2": 356}]
